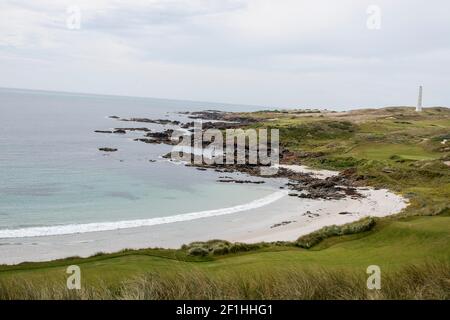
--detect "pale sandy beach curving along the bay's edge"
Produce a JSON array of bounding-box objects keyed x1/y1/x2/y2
[{"x1": 0, "y1": 166, "x2": 407, "y2": 264}]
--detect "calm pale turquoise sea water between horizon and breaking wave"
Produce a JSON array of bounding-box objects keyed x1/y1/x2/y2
[{"x1": 0, "y1": 89, "x2": 276, "y2": 230}]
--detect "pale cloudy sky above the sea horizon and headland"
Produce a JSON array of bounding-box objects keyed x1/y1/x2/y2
[{"x1": 0, "y1": 0, "x2": 450, "y2": 109}]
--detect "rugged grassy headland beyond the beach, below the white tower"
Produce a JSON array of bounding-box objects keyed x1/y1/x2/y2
[{"x1": 255, "y1": 108, "x2": 450, "y2": 215}]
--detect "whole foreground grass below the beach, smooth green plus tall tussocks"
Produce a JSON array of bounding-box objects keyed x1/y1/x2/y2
[{"x1": 0, "y1": 215, "x2": 450, "y2": 299}]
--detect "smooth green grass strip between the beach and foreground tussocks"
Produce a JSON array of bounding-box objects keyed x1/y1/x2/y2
[{"x1": 0, "y1": 210, "x2": 450, "y2": 284}]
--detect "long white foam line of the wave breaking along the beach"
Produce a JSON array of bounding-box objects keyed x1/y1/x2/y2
[{"x1": 0, "y1": 190, "x2": 287, "y2": 239}]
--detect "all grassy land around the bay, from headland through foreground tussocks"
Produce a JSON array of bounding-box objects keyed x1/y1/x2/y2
[{"x1": 0, "y1": 107, "x2": 450, "y2": 299}]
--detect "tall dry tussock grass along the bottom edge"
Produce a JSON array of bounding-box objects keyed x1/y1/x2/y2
[{"x1": 0, "y1": 263, "x2": 450, "y2": 300}]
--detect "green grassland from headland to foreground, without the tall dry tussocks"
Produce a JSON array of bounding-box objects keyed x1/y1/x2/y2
[{"x1": 0, "y1": 109, "x2": 450, "y2": 298}]
